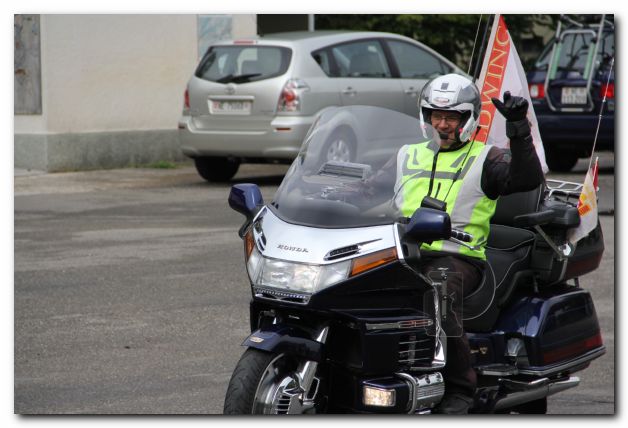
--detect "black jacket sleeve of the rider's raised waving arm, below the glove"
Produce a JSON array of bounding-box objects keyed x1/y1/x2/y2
[{"x1": 482, "y1": 119, "x2": 545, "y2": 199}]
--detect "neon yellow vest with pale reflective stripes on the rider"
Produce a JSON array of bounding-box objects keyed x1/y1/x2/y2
[{"x1": 395, "y1": 143, "x2": 496, "y2": 260}]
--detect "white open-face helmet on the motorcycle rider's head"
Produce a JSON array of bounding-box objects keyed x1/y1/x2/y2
[{"x1": 418, "y1": 74, "x2": 482, "y2": 143}]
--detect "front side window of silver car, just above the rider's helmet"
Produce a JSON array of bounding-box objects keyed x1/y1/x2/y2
[{"x1": 386, "y1": 40, "x2": 451, "y2": 79}]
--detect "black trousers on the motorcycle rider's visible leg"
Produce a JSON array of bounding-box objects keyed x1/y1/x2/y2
[{"x1": 421, "y1": 256, "x2": 483, "y2": 397}]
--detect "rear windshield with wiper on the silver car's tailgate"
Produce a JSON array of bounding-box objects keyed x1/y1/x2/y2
[{"x1": 195, "y1": 46, "x2": 292, "y2": 83}]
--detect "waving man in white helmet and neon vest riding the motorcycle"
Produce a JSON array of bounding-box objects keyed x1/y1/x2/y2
[{"x1": 395, "y1": 74, "x2": 544, "y2": 414}]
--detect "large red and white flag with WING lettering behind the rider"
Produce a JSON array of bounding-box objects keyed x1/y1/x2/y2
[{"x1": 475, "y1": 15, "x2": 548, "y2": 173}]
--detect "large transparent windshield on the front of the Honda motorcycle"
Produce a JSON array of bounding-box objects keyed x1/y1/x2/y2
[{"x1": 270, "y1": 106, "x2": 438, "y2": 228}]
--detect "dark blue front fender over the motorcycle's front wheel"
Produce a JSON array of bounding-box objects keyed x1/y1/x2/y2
[{"x1": 242, "y1": 324, "x2": 323, "y2": 362}]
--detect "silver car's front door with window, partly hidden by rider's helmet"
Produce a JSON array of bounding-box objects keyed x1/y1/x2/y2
[{"x1": 385, "y1": 39, "x2": 454, "y2": 116}]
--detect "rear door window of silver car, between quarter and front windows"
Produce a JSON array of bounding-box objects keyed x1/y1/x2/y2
[{"x1": 331, "y1": 40, "x2": 391, "y2": 77}]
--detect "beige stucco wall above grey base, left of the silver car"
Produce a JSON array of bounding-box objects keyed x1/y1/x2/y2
[{"x1": 14, "y1": 15, "x2": 256, "y2": 134}]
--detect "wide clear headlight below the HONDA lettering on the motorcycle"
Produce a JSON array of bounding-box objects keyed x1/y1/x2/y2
[{"x1": 247, "y1": 248, "x2": 351, "y2": 294}]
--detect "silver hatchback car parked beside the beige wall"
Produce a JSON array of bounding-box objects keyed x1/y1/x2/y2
[{"x1": 179, "y1": 31, "x2": 464, "y2": 181}]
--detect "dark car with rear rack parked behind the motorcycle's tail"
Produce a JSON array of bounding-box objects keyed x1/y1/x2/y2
[{"x1": 527, "y1": 19, "x2": 615, "y2": 172}]
